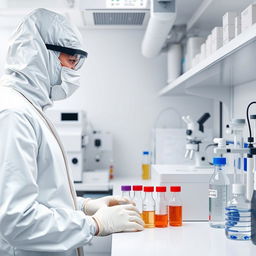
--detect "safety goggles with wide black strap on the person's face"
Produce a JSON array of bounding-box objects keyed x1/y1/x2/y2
[{"x1": 45, "y1": 44, "x2": 88, "y2": 70}]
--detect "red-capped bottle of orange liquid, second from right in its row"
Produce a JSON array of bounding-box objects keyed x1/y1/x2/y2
[{"x1": 155, "y1": 186, "x2": 168, "y2": 228}]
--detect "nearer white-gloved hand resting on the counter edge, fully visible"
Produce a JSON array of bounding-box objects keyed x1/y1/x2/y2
[{"x1": 92, "y1": 204, "x2": 144, "y2": 236}]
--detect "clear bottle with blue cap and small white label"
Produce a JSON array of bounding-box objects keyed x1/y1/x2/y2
[{"x1": 209, "y1": 157, "x2": 229, "y2": 228}]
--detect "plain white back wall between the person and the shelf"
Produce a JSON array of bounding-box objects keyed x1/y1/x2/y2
[{"x1": 0, "y1": 26, "x2": 213, "y2": 176}]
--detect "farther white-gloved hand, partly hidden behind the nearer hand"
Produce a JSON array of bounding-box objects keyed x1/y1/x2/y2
[{"x1": 83, "y1": 196, "x2": 135, "y2": 215}]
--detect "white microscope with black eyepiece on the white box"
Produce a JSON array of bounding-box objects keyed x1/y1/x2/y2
[{"x1": 182, "y1": 113, "x2": 210, "y2": 167}]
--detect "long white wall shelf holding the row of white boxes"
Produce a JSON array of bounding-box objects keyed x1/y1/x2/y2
[{"x1": 159, "y1": 24, "x2": 256, "y2": 100}]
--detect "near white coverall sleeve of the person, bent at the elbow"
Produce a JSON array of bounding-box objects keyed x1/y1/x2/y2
[{"x1": 0, "y1": 110, "x2": 96, "y2": 252}]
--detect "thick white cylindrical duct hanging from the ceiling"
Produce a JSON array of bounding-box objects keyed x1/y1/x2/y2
[{"x1": 142, "y1": 0, "x2": 176, "y2": 58}]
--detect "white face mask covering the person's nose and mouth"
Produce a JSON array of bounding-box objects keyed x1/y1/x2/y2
[{"x1": 50, "y1": 67, "x2": 80, "y2": 101}]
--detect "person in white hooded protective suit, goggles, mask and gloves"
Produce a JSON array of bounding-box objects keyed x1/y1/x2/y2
[{"x1": 0, "y1": 9, "x2": 144, "y2": 256}]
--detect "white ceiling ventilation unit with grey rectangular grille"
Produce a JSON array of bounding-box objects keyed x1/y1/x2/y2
[{"x1": 80, "y1": 0, "x2": 149, "y2": 29}]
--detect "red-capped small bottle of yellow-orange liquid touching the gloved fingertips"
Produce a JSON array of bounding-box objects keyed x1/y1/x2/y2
[{"x1": 142, "y1": 186, "x2": 155, "y2": 228}]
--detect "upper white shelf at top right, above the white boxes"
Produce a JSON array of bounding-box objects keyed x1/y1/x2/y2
[{"x1": 187, "y1": 0, "x2": 252, "y2": 33}]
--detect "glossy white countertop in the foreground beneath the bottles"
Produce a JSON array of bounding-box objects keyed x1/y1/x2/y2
[{"x1": 111, "y1": 222, "x2": 256, "y2": 256}]
